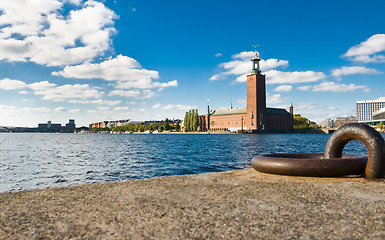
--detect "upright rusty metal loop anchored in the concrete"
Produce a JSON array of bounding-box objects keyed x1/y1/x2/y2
[{"x1": 325, "y1": 123, "x2": 385, "y2": 179}]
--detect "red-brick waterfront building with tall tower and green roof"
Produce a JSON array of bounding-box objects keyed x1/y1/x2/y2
[{"x1": 199, "y1": 52, "x2": 294, "y2": 132}]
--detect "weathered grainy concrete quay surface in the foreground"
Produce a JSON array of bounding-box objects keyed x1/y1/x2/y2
[{"x1": 0, "y1": 169, "x2": 385, "y2": 239}]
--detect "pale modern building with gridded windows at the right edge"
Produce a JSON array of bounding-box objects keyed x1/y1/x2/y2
[{"x1": 356, "y1": 100, "x2": 385, "y2": 125}]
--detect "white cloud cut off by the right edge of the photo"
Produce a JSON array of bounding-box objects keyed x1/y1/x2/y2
[{"x1": 343, "y1": 34, "x2": 385, "y2": 63}]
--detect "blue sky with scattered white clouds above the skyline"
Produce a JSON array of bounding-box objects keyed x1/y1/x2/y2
[{"x1": 0, "y1": 0, "x2": 385, "y2": 127}]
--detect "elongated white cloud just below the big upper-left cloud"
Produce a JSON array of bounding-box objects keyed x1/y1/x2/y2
[{"x1": 52, "y1": 55, "x2": 178, "y2": 89}]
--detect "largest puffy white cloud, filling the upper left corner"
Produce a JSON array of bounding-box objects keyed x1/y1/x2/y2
[{"x1": 0, "y1": 0, "x2": 117, "y2": 66}]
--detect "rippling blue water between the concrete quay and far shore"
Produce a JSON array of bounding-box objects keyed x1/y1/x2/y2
[{"x1": 0, "y1": 133, "x2": 367, "y2": 192}]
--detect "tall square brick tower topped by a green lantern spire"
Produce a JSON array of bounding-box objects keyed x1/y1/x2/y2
[{"x1": 245, "y1": 52, "x2": 266, "y2": 131}]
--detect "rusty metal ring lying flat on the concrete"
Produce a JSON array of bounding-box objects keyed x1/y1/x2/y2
[{"x1": 251, "y1": 153, "x2": 367, "y2": 177}]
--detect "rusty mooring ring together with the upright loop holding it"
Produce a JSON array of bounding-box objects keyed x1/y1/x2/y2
[{"x1": 251, "y1": 123, "x2": 385, "y2": 179}]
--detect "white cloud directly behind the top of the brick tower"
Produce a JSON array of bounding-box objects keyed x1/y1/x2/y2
[{"x1": 209, "y1": 52, "x2": 289, "y2": 82}]
